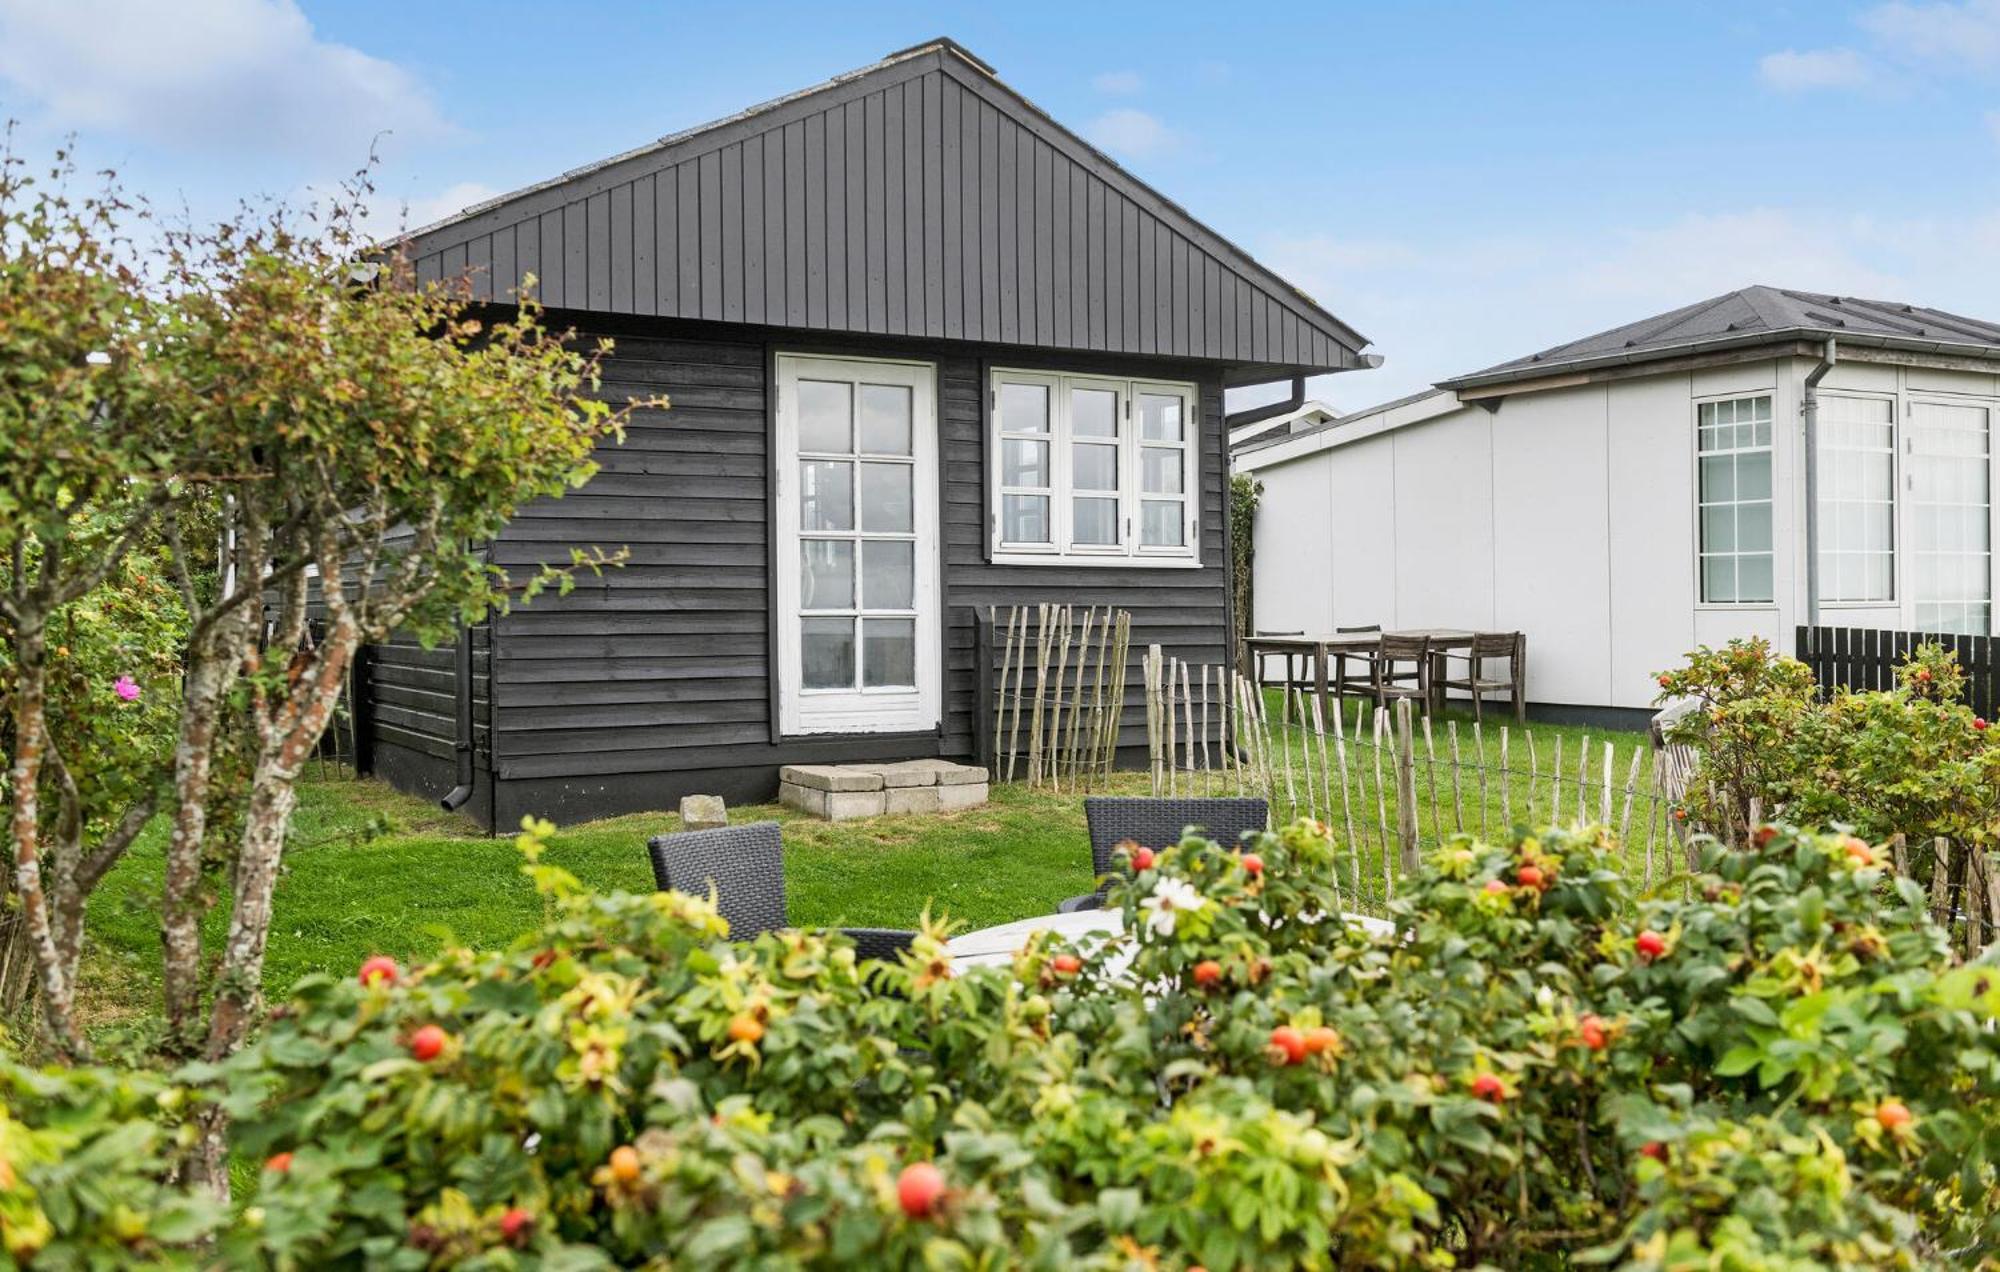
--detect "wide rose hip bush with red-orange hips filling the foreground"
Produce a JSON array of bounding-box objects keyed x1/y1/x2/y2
[{"x1": 3, "y1": 822, "x2": 2000, "y2": 1268}]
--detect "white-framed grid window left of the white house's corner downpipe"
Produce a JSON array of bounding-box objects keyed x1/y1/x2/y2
[{"x1": 1696, "y1": 394, "x2": 1776, "y2": 604}]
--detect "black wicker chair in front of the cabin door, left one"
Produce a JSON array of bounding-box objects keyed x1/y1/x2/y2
[{"x1": 646, "y1": 822, "x2": 916, "y2": 960}]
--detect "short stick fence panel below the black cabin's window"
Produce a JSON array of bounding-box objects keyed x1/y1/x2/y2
[{"x1": 986, "y1": 604, "x2": 1150, "y2": 790}]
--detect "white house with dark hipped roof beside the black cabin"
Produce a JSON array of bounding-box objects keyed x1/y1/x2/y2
[{"x1": 1236, "y1": 286, "x2": 2000, "y2": 714}]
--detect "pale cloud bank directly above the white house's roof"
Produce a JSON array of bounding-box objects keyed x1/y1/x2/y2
[{"x1": 1260, "y1": 208, "x2": 2000, "y2": 408}]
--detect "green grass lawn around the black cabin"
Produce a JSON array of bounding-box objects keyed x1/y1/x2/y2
[{"x1": 84, "y1": 696, "x2": 1638, "y2": 1028}]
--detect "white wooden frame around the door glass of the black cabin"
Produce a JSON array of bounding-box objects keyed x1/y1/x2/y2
[{"x1": 772, "y1": 354, "x2": 942, "y2": 736}]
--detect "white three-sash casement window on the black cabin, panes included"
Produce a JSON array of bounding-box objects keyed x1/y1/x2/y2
[{"x1": 990, "y1": 370, "x2": 1200, "y2": 566}]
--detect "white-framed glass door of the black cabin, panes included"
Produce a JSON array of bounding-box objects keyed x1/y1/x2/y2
[{"x1": 776, "y1": 354, "x2": 940, "y2": 734}]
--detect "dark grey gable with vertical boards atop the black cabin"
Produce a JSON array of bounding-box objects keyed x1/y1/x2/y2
[{"x1": 396, "y1": 40, "x2": 1368, "y2": 382}]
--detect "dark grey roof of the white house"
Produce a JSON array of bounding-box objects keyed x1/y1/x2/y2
[{"x1": 1440, "y1": 286, "x2": 2000, "y2": 388}]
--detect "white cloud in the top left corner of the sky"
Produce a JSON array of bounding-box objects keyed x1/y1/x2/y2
[{"x1": 0, "y1": 0, "x2": 448, "y2": 166}]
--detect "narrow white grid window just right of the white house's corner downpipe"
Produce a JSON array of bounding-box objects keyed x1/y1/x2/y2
[{"x1": 1820, "y1": 394, "x2": 1896, "y2": 602}]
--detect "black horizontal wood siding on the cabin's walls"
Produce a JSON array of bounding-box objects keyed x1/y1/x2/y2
[{"x1": 482, "y1": 316, "x2": 1228, "y2": 804}]
